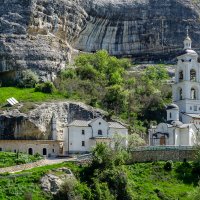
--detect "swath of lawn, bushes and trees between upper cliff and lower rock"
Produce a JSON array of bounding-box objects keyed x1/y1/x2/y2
[{"x1": 0, "y1": 50, "x2": 171, "y2": 133}]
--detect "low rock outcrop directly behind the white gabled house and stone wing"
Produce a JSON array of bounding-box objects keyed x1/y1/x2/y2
[{"x1": 0, "y1": 102, "x2": 105, "y2": 140}]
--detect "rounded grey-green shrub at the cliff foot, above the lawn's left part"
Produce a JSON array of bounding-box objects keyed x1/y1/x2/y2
[{"x1": 17, "y1": 69, "x2": 39, "y2": 88}]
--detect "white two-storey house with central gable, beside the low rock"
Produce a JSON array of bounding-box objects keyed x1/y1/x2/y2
[{"x1": 64, "y1": 117, "x2": 128, "y2": 154}]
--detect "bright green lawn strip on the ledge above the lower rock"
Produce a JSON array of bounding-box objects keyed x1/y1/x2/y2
[{"x1": 0, "y1": 87, "x2": 65, "y2": 105}]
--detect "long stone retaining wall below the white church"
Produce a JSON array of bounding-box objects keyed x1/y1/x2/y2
[{"x1": 131, "y1": 149, "x2": 195, "y2": 162}]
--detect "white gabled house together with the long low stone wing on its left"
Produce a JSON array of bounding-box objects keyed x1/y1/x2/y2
[{"x1": 0, "y1": 115, "x2": 128, "y2": 157}]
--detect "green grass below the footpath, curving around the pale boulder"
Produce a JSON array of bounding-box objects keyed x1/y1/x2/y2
[{"x1": 0, "y1": 163, "x2": 80, "y2": 200}]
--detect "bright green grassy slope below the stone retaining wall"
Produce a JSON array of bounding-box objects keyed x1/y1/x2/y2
[{"x1": 126, "y1": 162, "x2": 194, "y2": 200}]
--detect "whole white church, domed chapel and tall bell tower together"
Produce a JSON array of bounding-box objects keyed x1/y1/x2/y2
[{"x1": 149, "y1": 31, "x2": 200, "y2": 146}]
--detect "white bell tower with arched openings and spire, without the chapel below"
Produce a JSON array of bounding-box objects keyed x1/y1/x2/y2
[{"x1": 172, "y1": 29, "x2": 200, "y2": 114}]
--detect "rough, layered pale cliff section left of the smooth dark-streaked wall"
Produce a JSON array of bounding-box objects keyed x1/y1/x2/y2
[{"x1": 0, "y1": 0, "x2": 86, "y2": 80}]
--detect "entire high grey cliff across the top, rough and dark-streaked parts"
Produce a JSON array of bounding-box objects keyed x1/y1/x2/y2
[{"x1": 0, "y1": 0, "x2": 200, "y2": 80}]
